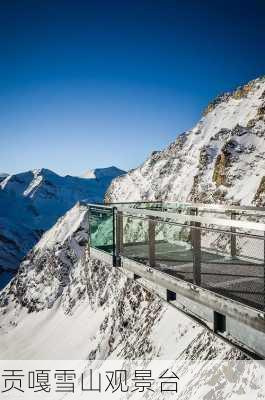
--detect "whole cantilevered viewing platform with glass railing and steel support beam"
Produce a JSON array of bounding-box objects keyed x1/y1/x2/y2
[{"x1": 84, "y1": 202, "x2": 265, "y2": 358}]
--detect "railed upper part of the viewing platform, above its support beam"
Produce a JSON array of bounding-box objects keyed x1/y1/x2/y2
[{"x1": 86, "y1": 203, "x2": 265, "y2": 312}]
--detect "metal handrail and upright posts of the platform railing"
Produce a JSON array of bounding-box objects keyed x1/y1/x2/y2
[{"x1": 87, "y1": 204, "x2": 265, "y2": 312}]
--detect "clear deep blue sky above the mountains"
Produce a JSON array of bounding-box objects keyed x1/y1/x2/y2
[{"x1": 0, "y1": 0, "x2": 265, "y2": 175}]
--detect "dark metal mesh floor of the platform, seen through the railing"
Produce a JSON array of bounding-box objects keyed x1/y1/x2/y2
[{"x1": 122, "y1": 242, "x2": 265, "y2": 311}]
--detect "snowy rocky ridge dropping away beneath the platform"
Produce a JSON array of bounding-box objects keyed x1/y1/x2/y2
[{"x1": 0, "y1": 204, "x2": 263, "y2": 399}]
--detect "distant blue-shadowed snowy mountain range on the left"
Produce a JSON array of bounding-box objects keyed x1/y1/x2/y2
[{"x1": 0, "y1": 167, "x2": 124, "y2": 285}]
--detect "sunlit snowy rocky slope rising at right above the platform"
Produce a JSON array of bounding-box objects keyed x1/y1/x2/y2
[{"x1": 106, "y1": 77, "x2": 265, "y2": 205}]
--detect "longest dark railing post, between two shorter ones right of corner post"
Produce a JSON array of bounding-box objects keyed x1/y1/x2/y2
[{"x1": 191, "y1": 222, "x2": 201, "y2": 286}]
